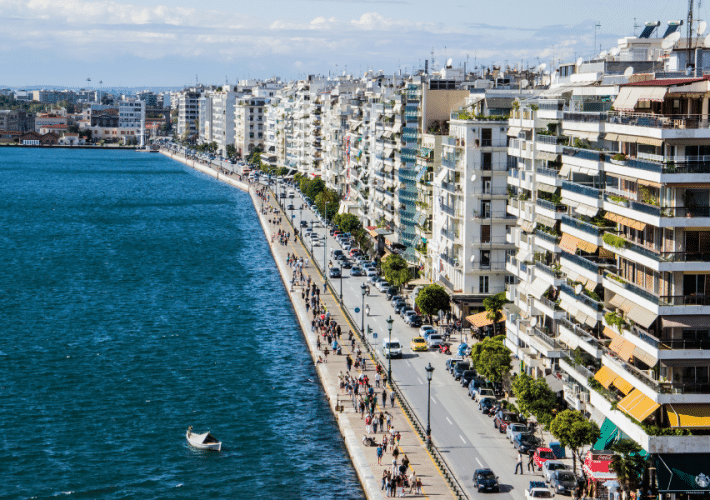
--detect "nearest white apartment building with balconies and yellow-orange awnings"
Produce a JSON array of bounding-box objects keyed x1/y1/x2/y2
[{"x1": 506, "y1": 26, "x2": 710, "y2": 496}]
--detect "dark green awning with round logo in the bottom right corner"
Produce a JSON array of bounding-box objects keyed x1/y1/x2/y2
[{"x1": 656, "y1": 453, "x2": 710, "y2": 493}]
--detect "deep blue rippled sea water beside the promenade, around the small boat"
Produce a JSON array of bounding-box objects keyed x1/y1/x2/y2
[{"x1": 0, "y1": 148, "x2": 364, "y2": 499}]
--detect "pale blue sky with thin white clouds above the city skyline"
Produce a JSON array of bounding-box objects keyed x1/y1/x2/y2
[{"x1": 0, "y1": 0, "x2": 710, "y2": 88}]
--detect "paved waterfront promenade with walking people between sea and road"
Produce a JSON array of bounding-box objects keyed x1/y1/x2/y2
[{"x1": 163, "y1": 151, "x2": 453, "y2": 499}]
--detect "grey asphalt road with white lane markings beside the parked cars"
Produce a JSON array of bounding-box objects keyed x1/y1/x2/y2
[{"x1": 276, "y1": 185, "x2": 542, "y2": 500}]
